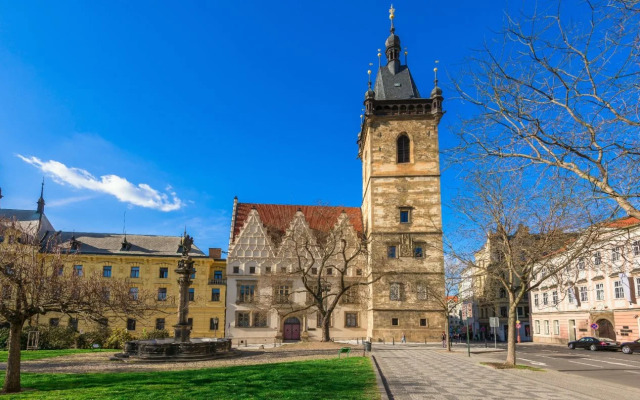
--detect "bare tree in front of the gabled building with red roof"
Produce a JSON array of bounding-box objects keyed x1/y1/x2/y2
[{"x1": 251, "y1": 208, "x2": 382, "y2": 342}]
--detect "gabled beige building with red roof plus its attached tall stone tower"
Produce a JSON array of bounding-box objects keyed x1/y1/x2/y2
[{"x1": 227, "y1": 7, "x2": 445, "y2": 342}]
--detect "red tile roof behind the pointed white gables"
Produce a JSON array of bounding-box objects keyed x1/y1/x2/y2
[{"x1": 233, "y1": 203, "x2": 362, "y2": 242}]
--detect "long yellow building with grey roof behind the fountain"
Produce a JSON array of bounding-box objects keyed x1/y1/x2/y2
[{"x1": 39, "y1": 232, "x2": 226, "y2": 338}]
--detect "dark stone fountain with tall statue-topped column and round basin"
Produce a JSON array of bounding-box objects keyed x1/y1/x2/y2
[{"x1": 117, "y1": 232, "x2": 231, "y2": 361}]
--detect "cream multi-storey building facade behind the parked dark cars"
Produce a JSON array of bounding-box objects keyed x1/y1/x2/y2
[{"x1": 531, "y1": 217, "x2": 640, "y2": 343}]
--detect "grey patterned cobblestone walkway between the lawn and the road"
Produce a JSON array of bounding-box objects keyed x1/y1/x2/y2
[{"x1": 373, "y1": 345, "x2": 640, "y2": 400}]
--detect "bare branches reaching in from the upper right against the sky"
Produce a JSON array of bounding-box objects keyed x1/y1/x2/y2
[{"x1": 455, "y1": 0, "x2": 640, "y2": 218}]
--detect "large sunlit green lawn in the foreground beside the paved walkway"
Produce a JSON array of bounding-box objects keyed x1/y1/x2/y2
[{"x1": 0, "y1": 357, "x2": 379, "y2": 400}]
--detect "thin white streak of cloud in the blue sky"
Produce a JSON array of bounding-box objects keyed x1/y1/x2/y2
[{"x1": 17, "y1": 154, "x2": 184, "y2": 211}]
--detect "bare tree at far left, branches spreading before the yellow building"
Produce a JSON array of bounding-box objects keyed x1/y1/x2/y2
[{"x1": 0, "y1": 220, "x2": 156, "y2": 393}]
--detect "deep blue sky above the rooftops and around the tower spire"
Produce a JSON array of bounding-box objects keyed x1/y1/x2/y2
[{"x1": 0, "y1": 0, "x2": 507, "y2": 249}]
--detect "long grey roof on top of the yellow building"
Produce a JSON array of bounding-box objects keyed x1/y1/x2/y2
[{"x1": 49, "y1": 232, "x2": 205, "y2": 257}]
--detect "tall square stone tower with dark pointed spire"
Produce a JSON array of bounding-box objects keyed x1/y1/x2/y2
[{"x1": 358, "y1": 8, "x2": 444, "y2": 341}]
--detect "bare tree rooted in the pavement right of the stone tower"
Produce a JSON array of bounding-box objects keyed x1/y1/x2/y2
[{"x1": 450, "y1": 167, "x2": 606, "y2": 365}]
